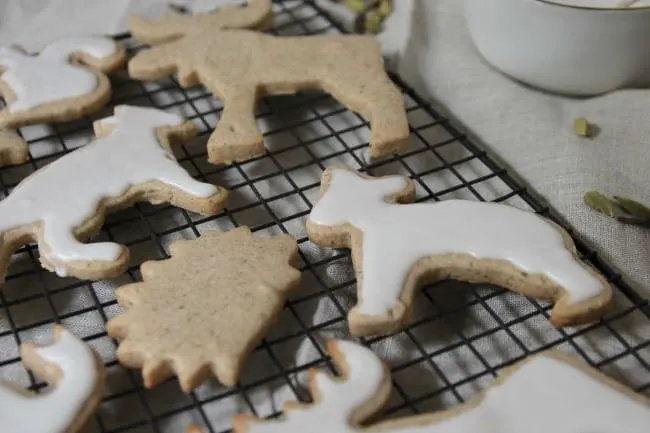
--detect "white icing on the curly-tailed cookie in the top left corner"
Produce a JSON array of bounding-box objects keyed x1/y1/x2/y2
[{"x1": 0, "y1": 36, "x2": 117, "y2": 112}]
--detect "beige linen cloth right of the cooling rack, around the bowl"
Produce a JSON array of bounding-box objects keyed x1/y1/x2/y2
[{"x1": 399, "y1": 0, "x2": 650, "y2": 296}]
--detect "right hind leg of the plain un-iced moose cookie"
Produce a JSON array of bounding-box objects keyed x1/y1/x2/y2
[{"x1": 324, "y1": 70, "x2": 409, "y2": 157}]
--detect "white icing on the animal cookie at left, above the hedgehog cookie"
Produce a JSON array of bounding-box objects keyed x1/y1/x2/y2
[{"x1": 0, "y1": 106, "x2": 218, "y2": 264}]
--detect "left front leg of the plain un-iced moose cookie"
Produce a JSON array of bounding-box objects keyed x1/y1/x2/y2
[{"x1": 208, "y1": 83, "x2": 264, "y2": 164}]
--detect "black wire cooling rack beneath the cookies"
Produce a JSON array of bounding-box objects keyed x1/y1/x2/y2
[{"x1": 0, "y1": 1, "x2": 650, "y2": 433}]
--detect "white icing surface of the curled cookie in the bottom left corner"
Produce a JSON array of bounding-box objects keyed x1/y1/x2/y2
[{"x1": 0, "y1": 330, "x2": 98, "y2": 433}]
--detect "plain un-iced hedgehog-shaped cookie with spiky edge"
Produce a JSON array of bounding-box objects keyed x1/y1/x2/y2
[{"x1": 107, "y1": 227, "x2": 300, "y2": 392}]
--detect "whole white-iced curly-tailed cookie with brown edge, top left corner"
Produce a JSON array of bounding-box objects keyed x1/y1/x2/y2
[{"x1": 0, "y1": 36, "x2": 125, "y2": 128}]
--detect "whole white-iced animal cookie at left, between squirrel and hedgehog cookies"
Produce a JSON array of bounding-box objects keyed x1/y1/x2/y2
[{"x1": 0, "y1": 106, "x2": 227, "y2": 280}]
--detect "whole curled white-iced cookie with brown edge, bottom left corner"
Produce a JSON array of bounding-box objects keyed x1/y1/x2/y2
[{"x1": 0, "y1": 326, "x2": 104, "y2": 433}]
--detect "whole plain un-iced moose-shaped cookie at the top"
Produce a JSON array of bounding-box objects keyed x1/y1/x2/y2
[{"x1": 129, "y1": 0, "x2": 409, "y2": 163}]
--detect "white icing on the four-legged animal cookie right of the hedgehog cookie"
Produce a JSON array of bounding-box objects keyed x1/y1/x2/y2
[{"x1": 309, "y1": 169, "x2": 604, "y2": 315}]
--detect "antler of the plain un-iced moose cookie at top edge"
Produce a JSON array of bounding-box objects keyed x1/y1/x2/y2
[{"x1": 130, "y1": 0, "x2": 273, "y2": 44}]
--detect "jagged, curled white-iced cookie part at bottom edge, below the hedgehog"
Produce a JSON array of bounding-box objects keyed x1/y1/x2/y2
[{"x1": 233, "y1": 340, "x2": 391, "y2": 433}]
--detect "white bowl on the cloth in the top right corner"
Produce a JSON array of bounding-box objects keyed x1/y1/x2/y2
[{"x1": 465, "y1": 0, "x2": 650, "y2": 96}]
